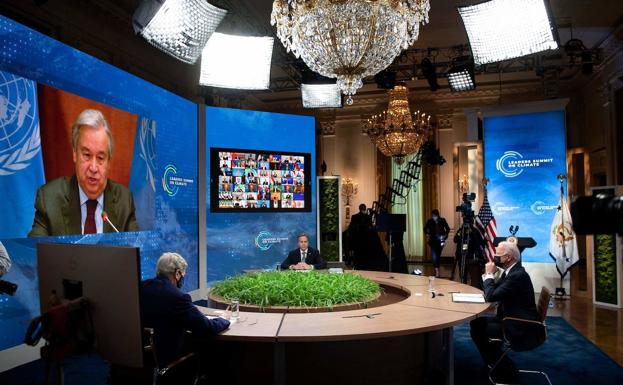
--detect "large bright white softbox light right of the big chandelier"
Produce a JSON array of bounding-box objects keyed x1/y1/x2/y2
[{"x1": 458, "y1": 0, "x2": 558, "y2": 65}]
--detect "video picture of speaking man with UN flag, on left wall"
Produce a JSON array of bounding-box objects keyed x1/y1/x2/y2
[{"x1": 0, "y1": 79, "x2": 156, "y2": 238}]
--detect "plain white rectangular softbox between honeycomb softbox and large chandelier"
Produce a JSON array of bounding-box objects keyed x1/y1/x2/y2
[{"x1": 199, "y1": 32, "x2": 273, "y2": 90}]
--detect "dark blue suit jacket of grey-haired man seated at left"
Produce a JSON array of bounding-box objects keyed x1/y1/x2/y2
[{"x1": 140, "y1": 276, "x2": 229, "y2": 367}]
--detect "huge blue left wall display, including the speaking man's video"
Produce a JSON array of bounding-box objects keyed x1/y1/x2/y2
[{"x1": 0, "y1": 16, "x2": 199, "y2": 354}]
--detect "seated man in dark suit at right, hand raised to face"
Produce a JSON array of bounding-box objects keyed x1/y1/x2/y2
[{"x1": 470, "y1": 241, "x2": 538, "y2": 384}]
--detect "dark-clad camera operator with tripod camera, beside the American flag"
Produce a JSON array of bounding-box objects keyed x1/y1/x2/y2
[{"x1": 452, "y1": 193, "x2": 484, "y2": 288}]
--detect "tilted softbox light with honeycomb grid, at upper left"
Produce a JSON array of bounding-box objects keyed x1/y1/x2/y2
[{"x1": 132, "y1": 0, "x2": 227, "y2": 64}]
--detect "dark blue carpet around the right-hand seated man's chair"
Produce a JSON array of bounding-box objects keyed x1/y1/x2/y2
[{"x1": 454, "y1": 317, "x2": 623, "y2": 385}]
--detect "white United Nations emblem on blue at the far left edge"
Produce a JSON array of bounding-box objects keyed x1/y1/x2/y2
[{"x1": 0, "y1": 71, "x2": 41, "y2": 176}]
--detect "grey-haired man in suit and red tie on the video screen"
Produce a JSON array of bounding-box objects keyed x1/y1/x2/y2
[{"x1": 28, "y1": 110, "x2": 138, "y2": 237}]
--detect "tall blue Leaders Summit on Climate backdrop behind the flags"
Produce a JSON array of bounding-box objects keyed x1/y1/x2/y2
[{"x1": 484, "y1": 111, "x2": 566, "y2": 263}]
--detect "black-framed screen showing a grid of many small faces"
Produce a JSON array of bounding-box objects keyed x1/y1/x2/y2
[{"x1": 210, "y1": 148, "x2": 311, "y2": 212}]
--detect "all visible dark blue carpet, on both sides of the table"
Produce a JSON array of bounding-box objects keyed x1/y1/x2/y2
[{"x1": 0, "y1": 317, "x2": 623, "y2": 385}]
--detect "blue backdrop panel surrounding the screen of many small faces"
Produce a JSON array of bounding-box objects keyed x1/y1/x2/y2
[{"x1": 206, "y1": 107, "x2": 316, "y2": 284}]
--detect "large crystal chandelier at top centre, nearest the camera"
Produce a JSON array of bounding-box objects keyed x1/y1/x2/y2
[{"x1": 270, "y1": 0, "x2": 430, "y2": 105}]
